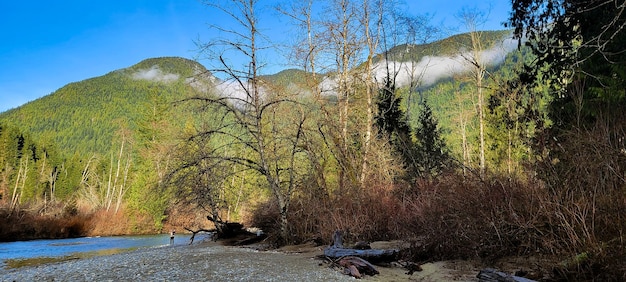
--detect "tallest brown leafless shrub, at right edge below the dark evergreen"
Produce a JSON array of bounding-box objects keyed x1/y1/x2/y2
[{"x1": 537, "y1": 112, "x2": 626, "y2": 280}]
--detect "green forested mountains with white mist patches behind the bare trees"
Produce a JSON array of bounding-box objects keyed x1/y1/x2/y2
[{"x1": 0, "y1": 31, "x2": 510, "y2": 230}]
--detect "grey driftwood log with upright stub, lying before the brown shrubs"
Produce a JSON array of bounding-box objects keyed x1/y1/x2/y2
[{"x1": 324, "y1": 231, "x2": 399, "y2": 263}]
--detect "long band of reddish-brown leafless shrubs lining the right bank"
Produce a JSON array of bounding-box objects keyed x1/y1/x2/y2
[{"x1": 251, "y1": 121, "x2": 626, "y2": 280}]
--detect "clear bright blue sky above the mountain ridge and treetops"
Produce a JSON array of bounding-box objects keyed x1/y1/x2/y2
[{"x1": 0, "y1": 0, "x2": 510, "y2": 112}]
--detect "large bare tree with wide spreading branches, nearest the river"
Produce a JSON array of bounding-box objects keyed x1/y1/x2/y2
[{"x1": 189, "y1": 0, "x2": 306, "y2": 240}]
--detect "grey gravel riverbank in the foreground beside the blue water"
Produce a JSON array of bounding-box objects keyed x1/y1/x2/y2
[{"x1": 0, "y1": 243, "x2": 354, "y2": 282}]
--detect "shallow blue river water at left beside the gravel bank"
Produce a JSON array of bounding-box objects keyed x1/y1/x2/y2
[{"x1": 0, "y1": 234, "x2": 202, "y2": 268}]
